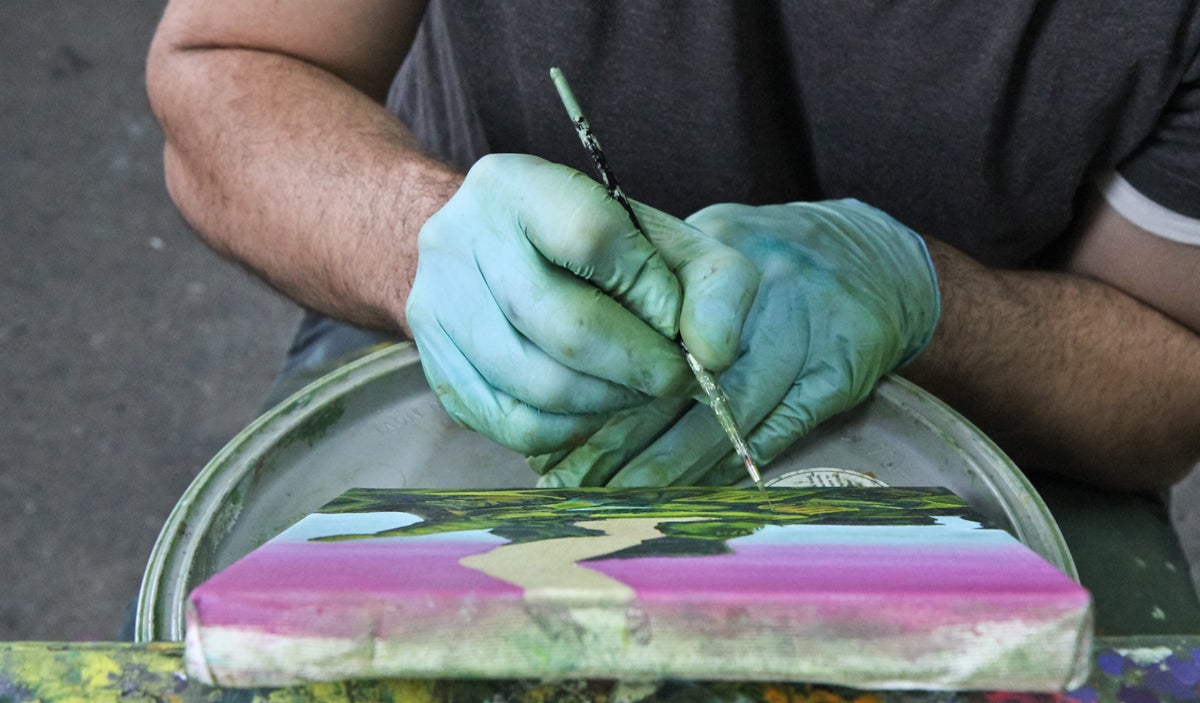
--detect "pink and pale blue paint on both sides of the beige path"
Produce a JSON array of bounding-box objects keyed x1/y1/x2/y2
[{"x1": 192, "y1": 513, "x2": 1088, "y2": 636}]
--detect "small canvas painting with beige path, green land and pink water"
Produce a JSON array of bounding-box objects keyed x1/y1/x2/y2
[{"x1": 187, "y1": 487, "x2": 1091, "y2": 691}]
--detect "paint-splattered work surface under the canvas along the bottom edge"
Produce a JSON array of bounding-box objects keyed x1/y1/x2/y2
[{"x1": 0, "y1": 636, "x2": 1200, "y2": 703}]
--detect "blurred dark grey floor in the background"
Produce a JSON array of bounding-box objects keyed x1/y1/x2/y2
[{"x1": 0, "y1": 0, "x2": 1200, "y2": 641}]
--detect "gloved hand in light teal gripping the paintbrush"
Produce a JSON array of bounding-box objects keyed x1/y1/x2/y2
[{"x1": 406, "y1": 155, "x2": 758, "y2": 455}]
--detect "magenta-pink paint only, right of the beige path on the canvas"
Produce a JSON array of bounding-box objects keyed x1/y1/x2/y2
[{"x1": 586, "y1": 545, "x2": 1090, "y2": 633}]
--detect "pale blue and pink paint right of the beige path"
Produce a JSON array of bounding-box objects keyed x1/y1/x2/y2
[{"x1": 586, "y1": 518, "x2": 1090, "y2": 629}]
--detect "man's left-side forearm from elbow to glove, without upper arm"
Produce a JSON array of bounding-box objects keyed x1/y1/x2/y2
[{"x1": 141, "y1": 48, "x2": 461, "y2": 330}]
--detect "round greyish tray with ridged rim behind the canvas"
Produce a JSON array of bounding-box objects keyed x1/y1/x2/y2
[{"x1": 136, "y1": 343, "x2": 1078, "y2": 642}]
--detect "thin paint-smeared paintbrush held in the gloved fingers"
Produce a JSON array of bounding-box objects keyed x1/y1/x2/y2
[{"x1": 550, "y1": 67, "x2": 763, "y2": 491}]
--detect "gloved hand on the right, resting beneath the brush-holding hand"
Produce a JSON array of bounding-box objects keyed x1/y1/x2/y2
[{"x1": 532, "y1": 195, "x2": 940, "y2": 487}]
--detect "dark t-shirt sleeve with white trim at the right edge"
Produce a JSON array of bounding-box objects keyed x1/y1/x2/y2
[{"x1": 1098, "y1": 51, "x2": 1200, "y2": 246}]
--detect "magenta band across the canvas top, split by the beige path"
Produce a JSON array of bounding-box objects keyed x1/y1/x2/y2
[{"x1": 196, "y1": 542, "x2": 1078, "y2": 596}]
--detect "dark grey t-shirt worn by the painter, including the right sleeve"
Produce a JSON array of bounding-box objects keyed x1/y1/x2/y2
[{"x1": 390, "y1": 0, "x2": 1200, "y2": 266}]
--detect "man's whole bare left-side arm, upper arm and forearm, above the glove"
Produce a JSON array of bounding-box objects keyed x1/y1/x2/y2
[{"x1": 146, "y1": 0, "x2": 461, "y2": 331}]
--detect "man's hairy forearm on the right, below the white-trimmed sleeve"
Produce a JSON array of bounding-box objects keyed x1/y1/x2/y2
[{"x1": 904, "y1": 241, "x2": 1200, "y2": 489}]
